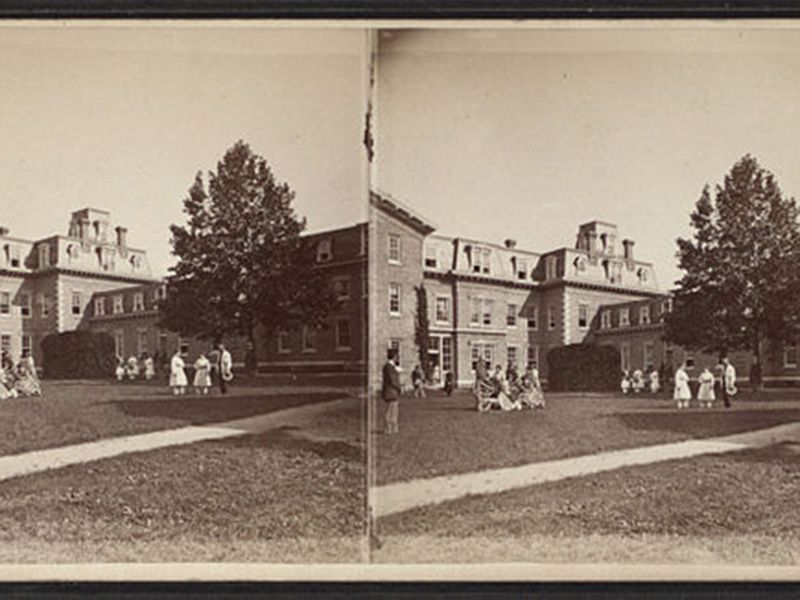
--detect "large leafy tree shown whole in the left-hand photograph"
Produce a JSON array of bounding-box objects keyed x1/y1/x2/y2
[{"x1": 159, "y1": 141, "x2": 335, "y2": 360}]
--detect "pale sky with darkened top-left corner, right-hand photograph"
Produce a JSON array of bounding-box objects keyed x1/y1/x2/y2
[{"x1": 373, "y1": 27, "x2": 800, "y2": 289}]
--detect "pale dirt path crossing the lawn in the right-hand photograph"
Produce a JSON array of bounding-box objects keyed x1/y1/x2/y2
[{"x1": 370, "y1": 423, "x2": 800, "y2": 517}]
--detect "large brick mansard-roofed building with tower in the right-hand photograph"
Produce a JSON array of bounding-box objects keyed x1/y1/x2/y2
[{"x1": 371, "y1": 192, "x2": 798, "y2": 392}]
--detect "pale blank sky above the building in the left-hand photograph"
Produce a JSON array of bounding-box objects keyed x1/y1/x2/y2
[{"x1": 0, "y1": 23, "x2": 367, "y2": 275}]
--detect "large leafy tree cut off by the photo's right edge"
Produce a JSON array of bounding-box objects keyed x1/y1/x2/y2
[{"x1": 666, "y1": 155, "x2": 800, "y2": 384}]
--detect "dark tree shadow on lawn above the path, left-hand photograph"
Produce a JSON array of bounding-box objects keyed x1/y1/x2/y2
[{"x1": 100, "y1": 392, "x2": 346, "y2": 425}]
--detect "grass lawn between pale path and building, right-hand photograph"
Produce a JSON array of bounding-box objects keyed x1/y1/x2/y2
[{"x1": 371, "y1": 389, "x2": 800, "y2": 484}]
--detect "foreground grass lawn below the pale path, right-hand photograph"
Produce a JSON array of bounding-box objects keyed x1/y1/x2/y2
[{"x1": 376, "y1": 444, "x2": 800, "y2": 564}]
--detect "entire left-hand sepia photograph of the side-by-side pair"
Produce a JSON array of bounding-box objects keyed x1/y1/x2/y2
[{"x1": 0, "y1": 22, "x2": 369, "y2": 564}]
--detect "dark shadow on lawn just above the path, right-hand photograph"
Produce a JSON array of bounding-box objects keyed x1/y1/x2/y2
[{"x1": 613, "y1": 408, "x2": 800, "y2": 436}]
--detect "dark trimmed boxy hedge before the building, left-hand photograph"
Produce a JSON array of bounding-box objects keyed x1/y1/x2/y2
[{"x1": 42, "y1": 331, "x2": 117, "y2": 379}]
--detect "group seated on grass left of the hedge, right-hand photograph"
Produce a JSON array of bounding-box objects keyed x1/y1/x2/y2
[{"x1": 474, "y1": 360, "x2": 545, "y2": 412}]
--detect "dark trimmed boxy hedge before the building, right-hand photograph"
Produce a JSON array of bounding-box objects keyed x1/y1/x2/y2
[{"x1": 547, "y1": 344, "x2": 621, "y2": 392}]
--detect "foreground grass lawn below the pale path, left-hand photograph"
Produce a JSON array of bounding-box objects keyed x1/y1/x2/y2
[{"x1": 0, "y1": 397, "x2": 366, "y2": 562}]
